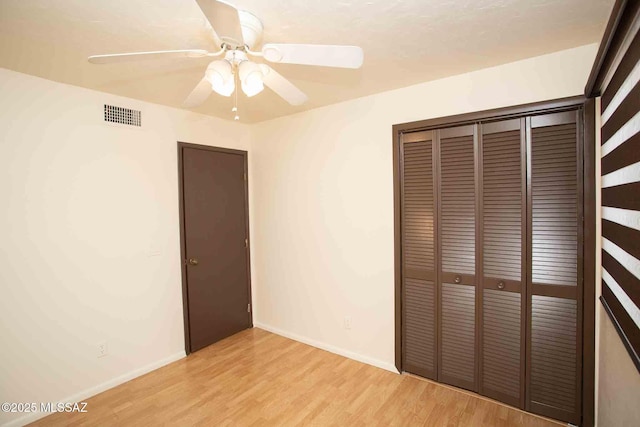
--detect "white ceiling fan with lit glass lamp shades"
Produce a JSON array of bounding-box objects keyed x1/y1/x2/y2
[{"x1": 89, "y1": 0, "x2": 364, "y2": 120}]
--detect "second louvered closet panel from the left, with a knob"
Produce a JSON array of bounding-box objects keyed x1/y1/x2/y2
[{"x1": 436, "y1": 126, "x2": 477, "y2": 391}]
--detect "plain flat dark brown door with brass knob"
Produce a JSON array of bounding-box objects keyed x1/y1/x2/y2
[{"x1": 179, "y1": 143, "x2": 251, "y2": 351}]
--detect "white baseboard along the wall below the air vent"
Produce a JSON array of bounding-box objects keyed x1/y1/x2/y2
[{"x1": 2, "y1": 351, "x2": 187, "y2": 427}]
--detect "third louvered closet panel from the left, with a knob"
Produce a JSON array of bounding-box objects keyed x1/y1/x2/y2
[{"x1": 478, "y1": 119, "x2": 526, "y2": 408}]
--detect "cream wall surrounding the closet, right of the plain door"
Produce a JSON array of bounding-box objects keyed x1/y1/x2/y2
[{"x1": 251, "y1": 45, "x2": 597, "y2": 370}]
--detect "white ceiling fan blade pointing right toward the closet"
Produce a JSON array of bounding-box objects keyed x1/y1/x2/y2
[{"x1": 262, "y1": 43, "x2": 364, "y2": 68}]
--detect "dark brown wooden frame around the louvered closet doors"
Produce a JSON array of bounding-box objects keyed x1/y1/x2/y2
[{"x1": 392, "y1": 96, "x2": 596, "y2": 426}]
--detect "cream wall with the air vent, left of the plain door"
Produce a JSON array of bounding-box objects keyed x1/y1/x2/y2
[{"x1": 0, "y1": 69, "x2": 251, "y2": 424}]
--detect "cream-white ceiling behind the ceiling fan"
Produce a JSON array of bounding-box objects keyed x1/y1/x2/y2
[{"x1": 0, "y1": 0, "x2": 614, "y2": 123}]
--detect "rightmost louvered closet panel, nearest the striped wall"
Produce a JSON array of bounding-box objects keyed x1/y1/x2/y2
[{"x1": 527, "y1": 111, "x2": 582, "y2": 425}]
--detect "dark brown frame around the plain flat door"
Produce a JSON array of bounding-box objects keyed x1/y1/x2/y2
[{"x1": 178, "y1": 141, "x2": 253, "y2": 355}]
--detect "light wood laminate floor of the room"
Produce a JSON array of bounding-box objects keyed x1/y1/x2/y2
[{"x1": 33, "y1": 329, "x2": 561, "y2": 427}]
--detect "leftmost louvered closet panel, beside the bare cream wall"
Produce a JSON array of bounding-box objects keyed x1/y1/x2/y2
[{"x1": 401, "y1": 131, "x2": 436, "y2": 379}]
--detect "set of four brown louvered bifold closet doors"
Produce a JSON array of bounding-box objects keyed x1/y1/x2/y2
[{"x1": 398, "y1": 107, "x2": 583, "y2": 425}]
